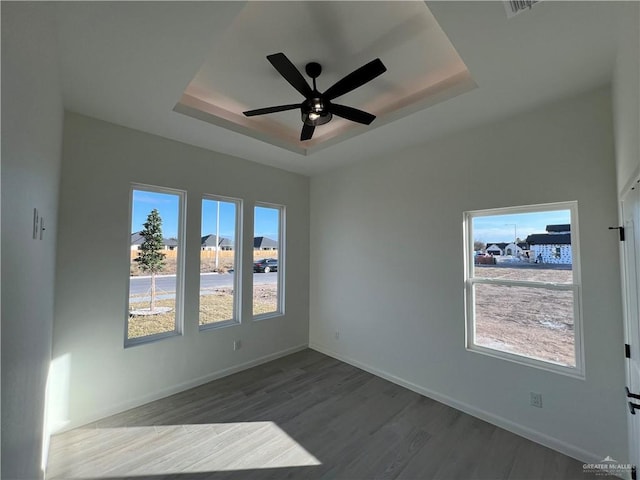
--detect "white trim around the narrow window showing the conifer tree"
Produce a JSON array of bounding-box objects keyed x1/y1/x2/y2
[{"x1": 124, "y1": 183, "x2": 187, "y2": 348}]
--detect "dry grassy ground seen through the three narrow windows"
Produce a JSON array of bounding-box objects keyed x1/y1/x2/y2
[{"x1": 128, "y1": 285, "x2": 277, "y2": 339}]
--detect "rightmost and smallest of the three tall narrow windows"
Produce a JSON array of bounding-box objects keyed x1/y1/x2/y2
[{"x1": 253, "y1": 204, "x2": 284, "y2": 318}]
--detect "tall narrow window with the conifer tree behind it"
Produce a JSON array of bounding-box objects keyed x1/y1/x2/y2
[{"x1": 125, "y1": 185, "x2": 185, "y2": 345}]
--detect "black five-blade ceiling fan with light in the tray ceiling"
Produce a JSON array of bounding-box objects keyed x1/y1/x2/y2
[{"x1": 242, "y1": 53, "x2": 387, "y2": 141}]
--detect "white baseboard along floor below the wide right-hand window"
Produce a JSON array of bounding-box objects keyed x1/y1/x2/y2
[{"x1": 309, "y1": 342, "x2": 603, "y2": 463}]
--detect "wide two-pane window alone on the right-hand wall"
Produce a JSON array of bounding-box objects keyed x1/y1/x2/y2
[{"x1": 464, "y1": 202, "x2": 584, "y2": 377}]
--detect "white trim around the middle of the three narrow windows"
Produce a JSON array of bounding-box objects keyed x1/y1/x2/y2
[{"x1": 198, "y1": 194, "x2": 243, "y2": 332}]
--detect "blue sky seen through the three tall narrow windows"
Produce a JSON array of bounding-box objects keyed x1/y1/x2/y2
[{"x1": 131, "y1": 190, "x2": 279, "y2": 240}]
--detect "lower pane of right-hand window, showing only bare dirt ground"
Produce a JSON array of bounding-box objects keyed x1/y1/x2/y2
[{"x1": 474, "y1": 284, "x2": 576, "y2": 367}]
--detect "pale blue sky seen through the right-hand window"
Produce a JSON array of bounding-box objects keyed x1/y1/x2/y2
[{"x1": 473, "y1": 210, "x2": 571, "y2": 243}]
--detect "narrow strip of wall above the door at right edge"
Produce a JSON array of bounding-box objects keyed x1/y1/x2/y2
[{"x1": 613, "y1": 2, "x2": 640, "y2": 193}]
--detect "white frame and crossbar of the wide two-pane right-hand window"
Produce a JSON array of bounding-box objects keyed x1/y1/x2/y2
[{"x1": 463, "y1": 201, "x2": 585, "y2": 380}]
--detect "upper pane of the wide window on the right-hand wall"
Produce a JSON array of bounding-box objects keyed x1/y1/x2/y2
[{"x1": 471, "y1": 210, "x2": 573, "y2": 284}]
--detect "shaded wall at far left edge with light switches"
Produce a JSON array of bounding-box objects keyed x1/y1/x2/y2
[{"x1": 2, "y1": 2, "x2": 63, "y2": 480}]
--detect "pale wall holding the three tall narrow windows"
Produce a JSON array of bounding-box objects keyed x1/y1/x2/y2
[{"x1": 53, "y1": 112, "x2": 309, "y2": 428}]
